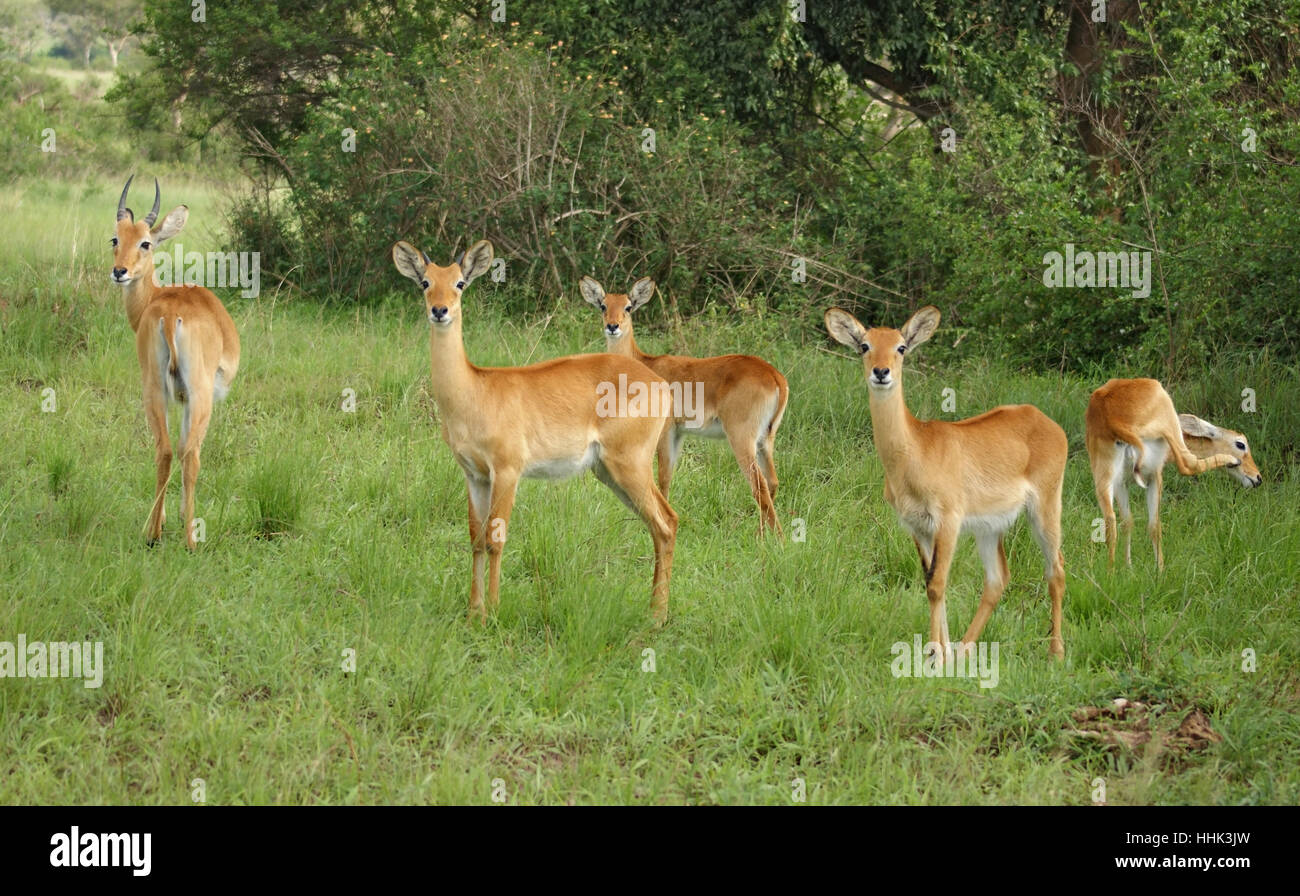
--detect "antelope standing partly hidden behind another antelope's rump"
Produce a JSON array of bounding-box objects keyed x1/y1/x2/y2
[{"x1": 580, "y1": 277, "x2": 790, "y2": 537}]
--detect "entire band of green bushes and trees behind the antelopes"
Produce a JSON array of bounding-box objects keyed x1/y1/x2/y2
[{"x1": 104, "y1": 0, "x2": 1300, "y2": 377}]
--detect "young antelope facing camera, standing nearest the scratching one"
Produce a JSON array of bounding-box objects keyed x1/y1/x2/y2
[{"x1": 826, "y1": 306, "x2": 1069, "y2": 659}]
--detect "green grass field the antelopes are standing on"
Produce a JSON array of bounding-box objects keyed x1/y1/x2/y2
[{"x1": 0, "y1": 179, "x2": 1300, "y2": 804}]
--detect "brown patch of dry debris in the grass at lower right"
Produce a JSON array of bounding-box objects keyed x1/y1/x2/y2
[{"x1": 1066, "y1": 697, "x2": 1223, "y2": 767}]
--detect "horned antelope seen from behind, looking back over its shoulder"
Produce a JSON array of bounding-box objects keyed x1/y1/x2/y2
[{"x1": 112, "y1": 174, "x2": 239, "y2": 550}]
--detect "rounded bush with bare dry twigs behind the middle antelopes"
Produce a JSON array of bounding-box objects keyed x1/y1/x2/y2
[{"x1": 235, "y1": 34, "x2": 790, "y2": 311}]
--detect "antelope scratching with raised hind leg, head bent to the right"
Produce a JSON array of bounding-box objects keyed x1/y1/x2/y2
[{"x1": 1084, "y1": 380, "x2": 1264, "y2": 570}]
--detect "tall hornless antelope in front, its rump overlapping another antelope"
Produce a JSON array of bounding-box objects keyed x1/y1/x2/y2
[{"x1": 393, "y1": 239, "x2": 677, "y2": 623}]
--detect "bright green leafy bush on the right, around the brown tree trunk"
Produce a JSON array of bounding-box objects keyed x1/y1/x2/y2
[{"x1": 800, "y1": 0, "x2": 1300, "y2": 377}]
